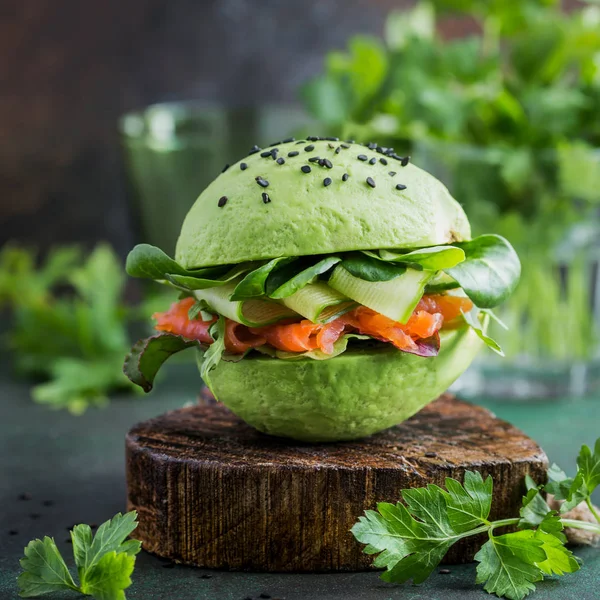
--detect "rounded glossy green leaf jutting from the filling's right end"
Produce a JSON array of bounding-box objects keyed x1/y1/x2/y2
[{"x1": 446, "y1": 234, "x2": 521, "y2": 308}]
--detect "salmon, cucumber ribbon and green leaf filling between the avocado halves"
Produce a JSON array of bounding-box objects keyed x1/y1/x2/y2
[{"x1": 125, "y1": 235, "x2": 520, "y2": 390}]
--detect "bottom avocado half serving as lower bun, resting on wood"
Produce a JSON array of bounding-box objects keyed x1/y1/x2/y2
[{"x1": 200, "y1": 327, "x2": 481, "y2": 442}]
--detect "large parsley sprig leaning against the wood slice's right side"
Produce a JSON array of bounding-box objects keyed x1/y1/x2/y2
[{"x1": 352, "y1": 438, "x2": 600, "y2": 600}]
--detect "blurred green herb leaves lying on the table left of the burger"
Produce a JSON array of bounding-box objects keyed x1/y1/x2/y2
[{"x1": 0, "y1": 245, "x2": 156, "y2": 414}]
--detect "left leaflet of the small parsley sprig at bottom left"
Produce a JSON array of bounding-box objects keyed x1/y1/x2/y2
[{"x1": 17, "y1": 537, "x2": 79, "y2": 598}]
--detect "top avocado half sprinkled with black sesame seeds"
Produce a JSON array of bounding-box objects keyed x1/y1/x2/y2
[{"x1": 175, "y1": 141, "x2": 471, "y2": 269}]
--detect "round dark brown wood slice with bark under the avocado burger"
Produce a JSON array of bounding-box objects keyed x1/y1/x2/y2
[{"x1": 126, "y1": 395, "x2": 548, "y2": 572}]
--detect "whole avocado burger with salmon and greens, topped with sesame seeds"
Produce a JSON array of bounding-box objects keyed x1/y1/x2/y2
[{"x1": 125, "y1": 137, "x2": 520, "y2": 442}]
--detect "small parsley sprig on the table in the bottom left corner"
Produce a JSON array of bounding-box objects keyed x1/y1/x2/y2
[{"x1": 18, "y1": 511, "x2": 141, "y2": 600}]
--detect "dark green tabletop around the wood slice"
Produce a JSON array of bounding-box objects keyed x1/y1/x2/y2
[{"x1": 0, "y1": 365, "x2": 600, "y2": 600}]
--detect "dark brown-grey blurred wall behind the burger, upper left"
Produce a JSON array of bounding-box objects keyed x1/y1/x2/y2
[{"x1": 0, "y1": 0, "x2": 418, "y2": 255}]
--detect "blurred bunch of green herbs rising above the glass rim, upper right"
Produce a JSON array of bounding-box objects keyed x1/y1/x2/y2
[{"x1": 302, "y1": 0, "x2": 600, "y2": 149}]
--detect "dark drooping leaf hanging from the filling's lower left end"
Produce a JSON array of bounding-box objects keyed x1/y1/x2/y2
[{"x1": 123, "y1": 333, "x2": 200, "y2": 392}]
